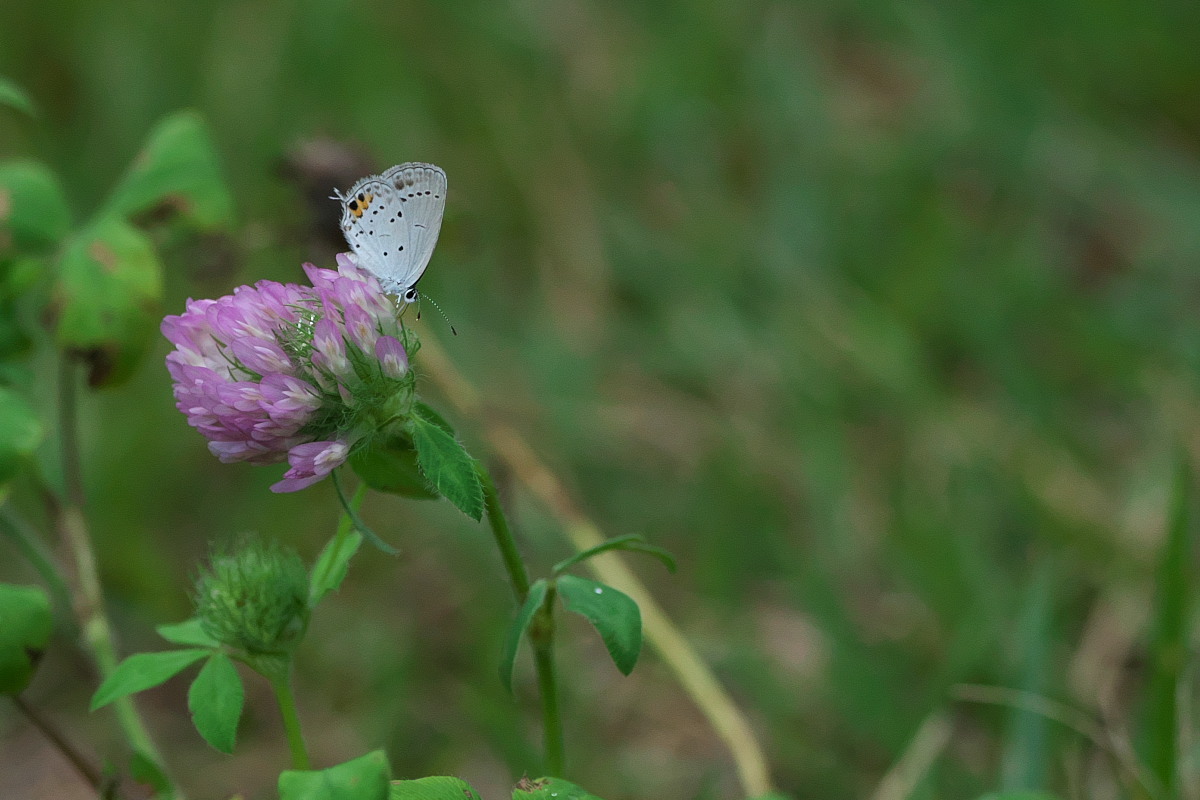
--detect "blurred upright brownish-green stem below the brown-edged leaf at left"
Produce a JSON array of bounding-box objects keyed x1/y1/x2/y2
[{"x1": 48, "y1": 355, "x2": 182, "y2": 798}]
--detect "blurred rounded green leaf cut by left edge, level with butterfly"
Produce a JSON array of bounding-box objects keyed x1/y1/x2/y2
[{"x1": 0, "y1": 161, "x2": 71, "y2": 253}]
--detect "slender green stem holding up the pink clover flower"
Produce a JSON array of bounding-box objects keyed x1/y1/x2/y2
[{"x1": 476, "y1": 467, "x2": 563, "y2": 777}]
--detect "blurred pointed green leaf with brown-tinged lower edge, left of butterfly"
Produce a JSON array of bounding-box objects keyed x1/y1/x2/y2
[{"x1": 100, "y1": 112, "x2": 234, "y2": 230}]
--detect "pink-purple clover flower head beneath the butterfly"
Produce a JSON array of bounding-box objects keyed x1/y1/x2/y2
[{"x1": 162, "y1": 253, "x2": 413, "y2": 492}]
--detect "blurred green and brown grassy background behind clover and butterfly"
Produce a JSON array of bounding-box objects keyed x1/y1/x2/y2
[{"x1": 0, "y1": 0, "x2": 1200, "y2": 800}]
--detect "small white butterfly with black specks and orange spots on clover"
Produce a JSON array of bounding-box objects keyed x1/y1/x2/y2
[{"x1": 334, "y1": 162, "x2": 446, "y2": 302}]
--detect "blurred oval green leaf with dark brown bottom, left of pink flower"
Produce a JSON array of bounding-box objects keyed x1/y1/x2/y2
[{"x1": 55, "y1": 218, "x2": 162, "y2": 386}]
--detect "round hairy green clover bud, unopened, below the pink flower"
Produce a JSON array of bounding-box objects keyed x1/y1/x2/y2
[{"x1": 196, "y1": 536, "x2": 308, "y2": 657}]
